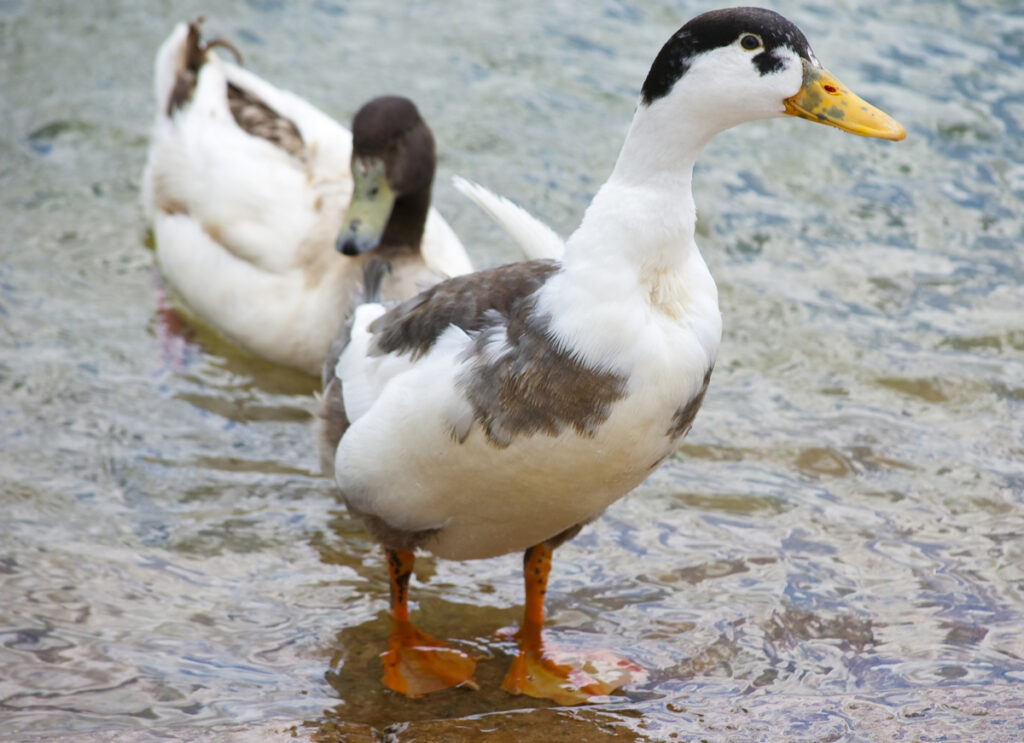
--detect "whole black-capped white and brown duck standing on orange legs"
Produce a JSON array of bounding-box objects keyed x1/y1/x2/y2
[{"x1": 321, "y1": 8, "x2": 904, "y2": 703}]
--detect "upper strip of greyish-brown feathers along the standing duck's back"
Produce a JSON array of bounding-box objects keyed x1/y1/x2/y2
[{"x1": 369, "y1": 260, "x2": 559, "y2": 357}]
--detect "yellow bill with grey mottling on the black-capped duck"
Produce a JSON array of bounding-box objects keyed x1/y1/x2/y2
[{"x1": 782, "y1": 59, "x2": 906, "y2": 141}]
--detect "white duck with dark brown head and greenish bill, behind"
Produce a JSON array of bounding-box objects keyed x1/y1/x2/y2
[{"x1": 142, "y1": 21, "x2": 472, "y2": 375}]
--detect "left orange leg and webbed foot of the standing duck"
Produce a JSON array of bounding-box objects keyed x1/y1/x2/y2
[{"x1": 381, "y1": 550, "x2": 477, "y2": 697}]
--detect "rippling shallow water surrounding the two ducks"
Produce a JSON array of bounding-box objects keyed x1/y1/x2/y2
[{"x1": 0, "y1": 0, "x2": 1024, "y2": 741}]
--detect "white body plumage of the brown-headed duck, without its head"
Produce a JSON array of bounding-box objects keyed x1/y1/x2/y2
[{"x1": 142, "y1": 24, "x2": 472, "y2": 374}]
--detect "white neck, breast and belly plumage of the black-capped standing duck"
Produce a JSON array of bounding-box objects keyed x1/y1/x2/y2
[{"x1": 334, "y1": 65, "x2": 729, "y2": 559}]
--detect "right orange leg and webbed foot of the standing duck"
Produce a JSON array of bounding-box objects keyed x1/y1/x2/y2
[{"x1": 502, "y1": 543, "x2": 645, "y2": 704}]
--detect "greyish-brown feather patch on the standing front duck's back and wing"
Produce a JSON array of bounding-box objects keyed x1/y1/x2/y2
[{"x1": 370, "y1": 260, "x2": 627, "y2": 447}]
